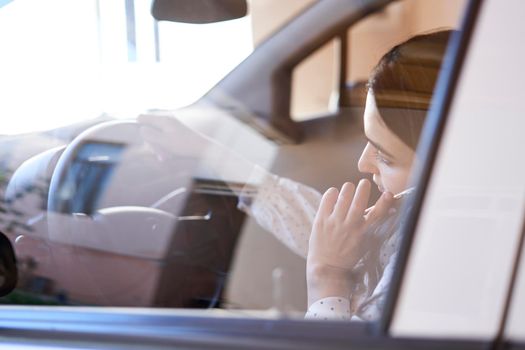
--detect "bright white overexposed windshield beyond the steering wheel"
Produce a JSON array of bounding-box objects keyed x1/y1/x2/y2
[{"x1": 0, "y1": 0, "x2": 253, "y2": 135}]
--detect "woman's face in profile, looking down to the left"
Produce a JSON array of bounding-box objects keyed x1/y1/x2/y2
[{"x1": 358, "y1": 92, "x2": 415, "y2": 195}]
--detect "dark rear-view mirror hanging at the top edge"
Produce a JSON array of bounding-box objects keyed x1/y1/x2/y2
[{"x1": 151, "y1": 0, "x2": 248, "y2": 24}]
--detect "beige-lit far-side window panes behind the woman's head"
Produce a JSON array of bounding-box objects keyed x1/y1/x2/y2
[{"x1": 290, "y1": 0, "x2": 466, "y2": 121}]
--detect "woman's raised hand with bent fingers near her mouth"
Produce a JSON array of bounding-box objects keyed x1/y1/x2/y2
[{"x1": 307, "y1": 180, "x2": 393, "y2": 305}]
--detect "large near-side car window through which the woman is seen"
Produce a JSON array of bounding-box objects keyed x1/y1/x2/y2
[{"x1": 0, "y1": 0, "x2": 463, "y2": 321}]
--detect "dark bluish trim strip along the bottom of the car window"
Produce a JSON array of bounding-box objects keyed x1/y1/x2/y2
[{"x1": 0, "y1": 307, "x2": 487, "y2": 350}]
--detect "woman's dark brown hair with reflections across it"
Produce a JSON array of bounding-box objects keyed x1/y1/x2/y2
[{"x1": 368, "y1": 30, "x2": 454, "y2": 150}]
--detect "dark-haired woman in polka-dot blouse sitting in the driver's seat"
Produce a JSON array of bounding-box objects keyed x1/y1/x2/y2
[{"x1": 240, "y1": 31, "x2": 451, "y2": 320}]
